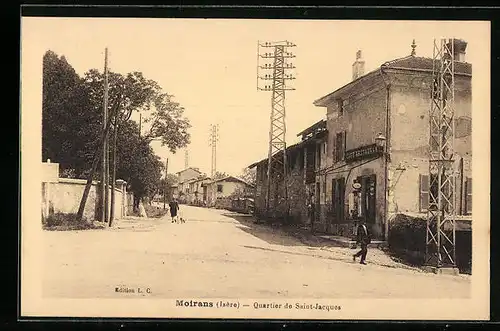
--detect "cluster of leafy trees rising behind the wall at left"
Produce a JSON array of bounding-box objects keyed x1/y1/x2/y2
[{"x1": 42, "y1": 51, "x2": 190, "y2": 205}]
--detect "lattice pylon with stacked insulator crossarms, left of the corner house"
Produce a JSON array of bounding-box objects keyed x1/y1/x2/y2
[{"x1": 257, "y1": 41, "x2": 296, "y2": 215}]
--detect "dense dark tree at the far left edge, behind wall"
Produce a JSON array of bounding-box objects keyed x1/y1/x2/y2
[{"x1": 42, "y1": 51, "x2": 99, "y2": 177}]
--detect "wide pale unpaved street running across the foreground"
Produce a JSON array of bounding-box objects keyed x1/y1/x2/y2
[{"x1": 43, "y1": 206, "x2": 471, "y2": 299}]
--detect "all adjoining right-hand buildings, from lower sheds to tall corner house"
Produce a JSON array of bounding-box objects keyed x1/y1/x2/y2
[{"x1": 249, "y1": 39, "x2": 472, "y2": 244}]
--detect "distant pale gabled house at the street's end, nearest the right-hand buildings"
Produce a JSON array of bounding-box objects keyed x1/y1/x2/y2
[{"x1": 203, "y1": 176, "x2": 254, "y2": 207}]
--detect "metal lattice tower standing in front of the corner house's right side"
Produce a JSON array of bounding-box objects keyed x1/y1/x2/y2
[{"x1": 426, "y1": 39, "x2": 456, "y2": 268}]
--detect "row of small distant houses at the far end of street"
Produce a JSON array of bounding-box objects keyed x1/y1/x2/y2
[{"x1": 173, "y1": 167, "x2": 254, "y2": 207}]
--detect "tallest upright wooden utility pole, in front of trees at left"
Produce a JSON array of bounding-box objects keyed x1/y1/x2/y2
[{"x1": 99, "y1": 48, "x2": 108, "y2": 222}]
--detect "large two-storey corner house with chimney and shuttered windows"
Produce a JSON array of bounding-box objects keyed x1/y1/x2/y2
[{"x1": 314, "y1": 40, "x2": 472, "y2": 239}]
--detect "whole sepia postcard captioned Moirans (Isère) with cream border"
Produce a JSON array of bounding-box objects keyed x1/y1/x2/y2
[{"x1": 20, "y1": 17, "x2": 490, "y2": 320}]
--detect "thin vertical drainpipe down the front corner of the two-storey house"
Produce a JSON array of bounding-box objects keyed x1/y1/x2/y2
[{"x1": 380, "y1": 66, "x2": 391, "y2": 243}]
